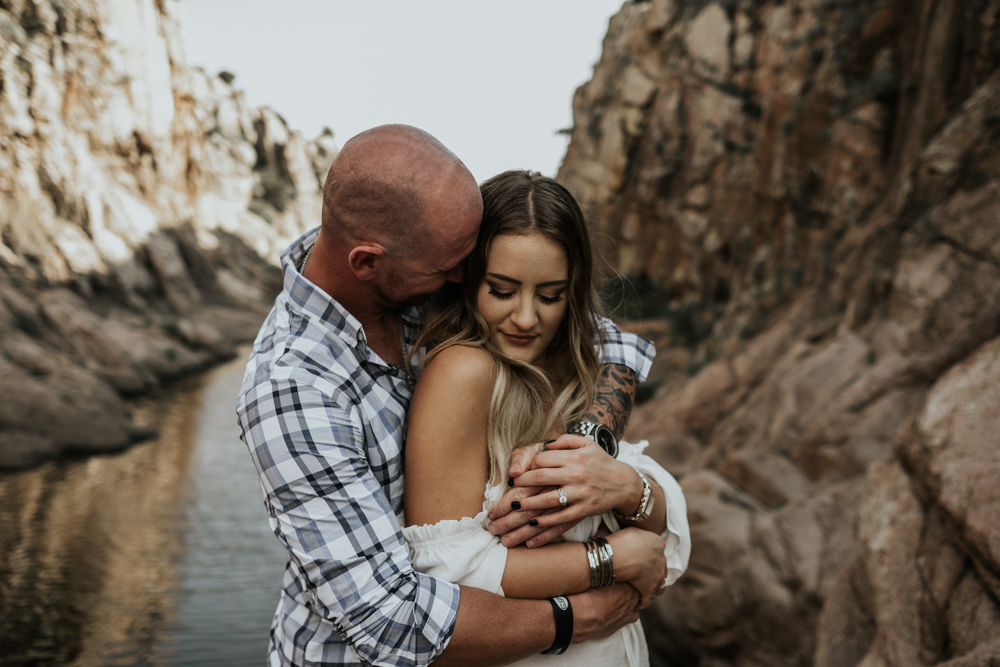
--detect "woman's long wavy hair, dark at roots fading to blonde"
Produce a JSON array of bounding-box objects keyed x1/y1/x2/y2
[{"x1": 414, "y1": 171, "x2": 602, "y2": 485}]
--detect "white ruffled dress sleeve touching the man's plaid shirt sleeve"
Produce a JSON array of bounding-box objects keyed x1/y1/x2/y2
[{"x1": 403, "y1": 489, "x2": 507, "y2": 595}]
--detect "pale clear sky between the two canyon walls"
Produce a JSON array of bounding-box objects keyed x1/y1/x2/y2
[{"x1": 181, "y1": 0, "x2": 622, "y2": 181}]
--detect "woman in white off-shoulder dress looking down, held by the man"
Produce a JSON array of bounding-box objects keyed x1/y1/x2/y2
[{"x1": 403, "y1": 171, "x2": 688, "y2": 665}]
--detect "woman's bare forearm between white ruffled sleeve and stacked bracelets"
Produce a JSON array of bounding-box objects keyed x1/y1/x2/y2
[{"x1": 501, "y1": 542, "x2": 590, "y2": 599}]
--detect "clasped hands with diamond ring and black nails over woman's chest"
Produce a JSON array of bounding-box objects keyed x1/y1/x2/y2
[{"x1": 490, "y1": 434, "x2": 642, "y2": 547}]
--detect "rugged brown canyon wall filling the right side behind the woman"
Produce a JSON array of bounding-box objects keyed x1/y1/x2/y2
[{"x1": 560, "y1": 0, "x2": 1000, "y2": 667}]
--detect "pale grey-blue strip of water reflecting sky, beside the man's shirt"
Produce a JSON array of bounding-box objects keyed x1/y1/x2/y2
[{"x1": 170, "y1": 357, "x2": 287, "y2": 667}]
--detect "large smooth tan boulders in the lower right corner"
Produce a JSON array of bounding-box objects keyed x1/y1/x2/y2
[{"x1": 816, "y1": 339, "x2": 1000, "y2": 667}]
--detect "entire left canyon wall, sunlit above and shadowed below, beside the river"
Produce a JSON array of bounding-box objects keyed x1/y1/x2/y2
[{"x1": 0, "y1": 0, "x2": 337, "y2": 467}]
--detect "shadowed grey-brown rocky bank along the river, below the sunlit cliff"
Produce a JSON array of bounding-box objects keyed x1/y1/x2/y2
[{"x1": 0, "y1": 228, "x2": 280, "y2": 470}]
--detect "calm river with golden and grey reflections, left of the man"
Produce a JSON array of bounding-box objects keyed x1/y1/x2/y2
[{"x1": 0, "y1": 357, "x2": 286, "y2": 667}]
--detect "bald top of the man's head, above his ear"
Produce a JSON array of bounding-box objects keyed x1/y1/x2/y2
[{"x1": 322, "y1": 125, "x2": 482, "y2": 259}]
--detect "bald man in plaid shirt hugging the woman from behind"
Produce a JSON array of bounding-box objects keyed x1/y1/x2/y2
[{"x1": 237, "y1": 126, "x2": 665, "y2": 666}]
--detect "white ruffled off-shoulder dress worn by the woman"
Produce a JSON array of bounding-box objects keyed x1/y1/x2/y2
[{"x1": 403, "y1": 440, "x2": 691, "y2": 667}]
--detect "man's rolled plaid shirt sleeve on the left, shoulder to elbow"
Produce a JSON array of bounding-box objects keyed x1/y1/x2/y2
[{"x1": 240, "y1": 378, "x2": 459, "y2": 666}]
